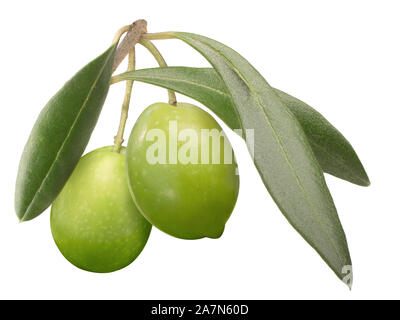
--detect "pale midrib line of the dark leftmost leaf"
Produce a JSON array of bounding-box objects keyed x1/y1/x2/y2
[{"x1": 20, "y1": 50, "x2": 113, "y2": 221}]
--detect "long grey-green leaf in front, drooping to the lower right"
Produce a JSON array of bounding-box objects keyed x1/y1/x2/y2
[{"x1": 169, "y1": 32, "x2": 351, "y2": 279}]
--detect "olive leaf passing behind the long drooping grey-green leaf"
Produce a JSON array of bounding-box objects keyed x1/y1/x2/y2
[{"x1": 116, "y1": 67, "x2": 370, "y2": 186}]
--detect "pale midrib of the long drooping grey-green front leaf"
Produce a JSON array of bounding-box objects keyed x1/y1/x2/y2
[{"x1": 181, "y1": 34, "x2": 343, "y2": 263}]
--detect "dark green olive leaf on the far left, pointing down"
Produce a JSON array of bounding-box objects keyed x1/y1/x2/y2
[{"x1": 15, "y1": 44, "x2": 116, "y2": 221}]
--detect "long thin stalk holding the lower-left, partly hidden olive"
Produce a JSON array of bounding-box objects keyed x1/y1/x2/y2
[{"x1": 114, "y1": 47, "x2": 136, "y2": 152}]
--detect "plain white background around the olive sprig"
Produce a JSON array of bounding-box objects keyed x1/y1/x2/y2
[{"x1": 0, "y1": 0, "x2": 400, "y2": 299}]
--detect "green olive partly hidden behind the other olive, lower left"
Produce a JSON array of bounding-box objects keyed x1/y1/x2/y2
[{"x1": 50, "y1": 147, "x2": 151, "y2": 273}]
